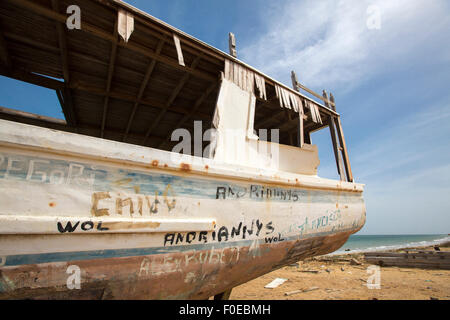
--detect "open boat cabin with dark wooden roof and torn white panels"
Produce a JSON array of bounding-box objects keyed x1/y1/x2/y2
[{"x1": 0, "y1": 0, "x2": 353, "y2": 182}]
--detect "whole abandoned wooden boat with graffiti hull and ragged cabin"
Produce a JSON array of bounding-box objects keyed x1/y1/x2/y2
[{"x1": 0, "y1": 0, "x2": 366, "y2": 299}]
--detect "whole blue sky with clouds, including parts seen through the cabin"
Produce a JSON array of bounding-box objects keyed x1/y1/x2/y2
[{"x1": 0, "y1": 0, "x2": 450, "y2": 234}]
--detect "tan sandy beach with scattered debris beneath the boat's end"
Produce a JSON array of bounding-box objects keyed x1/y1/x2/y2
[{"x1": 230, "y1": 244, "x2": 450, "y2": 300}]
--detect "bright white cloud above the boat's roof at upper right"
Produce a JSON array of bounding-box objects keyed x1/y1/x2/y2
[{"x1": 240, "y1": 0, "x2": 450, "y2": 90}]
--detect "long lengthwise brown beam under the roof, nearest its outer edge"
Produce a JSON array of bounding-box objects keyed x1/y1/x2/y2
[{"x1": 4, "y1": 0, "x2": 216, "y2": 82}]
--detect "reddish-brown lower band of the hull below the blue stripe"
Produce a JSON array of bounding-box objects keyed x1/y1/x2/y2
[{"x1": 0, "y1": 232, "x2": 352, "y2": 299}]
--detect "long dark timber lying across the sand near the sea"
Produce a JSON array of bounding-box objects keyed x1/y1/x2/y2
[{"x1": 364, "y1": 251, "x2": 450, "y2": 270}]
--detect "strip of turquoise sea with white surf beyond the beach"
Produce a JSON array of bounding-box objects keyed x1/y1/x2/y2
[{"x1": 329, "y1": 234, "x2": 450, "y2": 255}]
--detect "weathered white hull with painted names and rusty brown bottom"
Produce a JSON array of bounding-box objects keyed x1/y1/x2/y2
[{"x1": 0, "y1": 121, "x2": 366, "y2": 299}]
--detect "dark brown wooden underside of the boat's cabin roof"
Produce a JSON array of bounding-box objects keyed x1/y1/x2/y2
[{"x1": 0, "y1": 0, "x2": 339, "y2": 150}]
